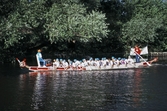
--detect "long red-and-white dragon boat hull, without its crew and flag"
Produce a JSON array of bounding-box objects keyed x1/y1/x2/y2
[{"x1": 16, "y1": 58, "x2": 158, "y2": 72}]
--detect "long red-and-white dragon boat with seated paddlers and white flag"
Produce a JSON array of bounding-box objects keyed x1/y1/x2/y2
[{"x1": 16, "y1": 46, "x2": 158, "y2": 72}]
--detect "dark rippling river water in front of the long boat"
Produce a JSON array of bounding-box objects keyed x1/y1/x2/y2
[{"x1": 0, "y1": 64, "x2": 167, "y2": 111}]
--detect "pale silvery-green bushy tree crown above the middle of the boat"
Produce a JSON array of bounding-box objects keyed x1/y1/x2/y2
[{"x1": 45, "y1": 2, "x2": 109, "y2": 42}]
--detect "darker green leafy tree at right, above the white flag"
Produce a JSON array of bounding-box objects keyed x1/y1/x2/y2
[{"x1": 121, "y1": 0, "x2": 164, "y2": 53}]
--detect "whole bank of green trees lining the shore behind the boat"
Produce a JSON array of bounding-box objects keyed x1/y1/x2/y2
[{"x1": 0, "y1": 0, "x2": 167, "y2": 61}]
